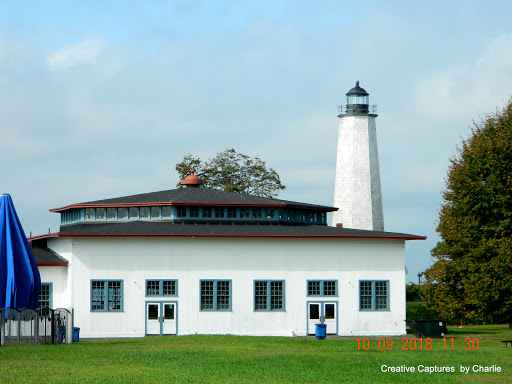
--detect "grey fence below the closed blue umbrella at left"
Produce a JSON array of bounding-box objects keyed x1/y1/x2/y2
[{"x1": 0, "y1": 308, "x2": 73, "y2": 346}]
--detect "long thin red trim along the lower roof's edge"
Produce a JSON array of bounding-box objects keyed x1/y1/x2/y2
[{"x1": 39, "y1": 233, "x2": 427, "y2": 240}]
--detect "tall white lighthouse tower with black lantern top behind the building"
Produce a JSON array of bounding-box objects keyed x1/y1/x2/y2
[{"x1": 332, "y1": 81, "x2": 384, "y2": 231}]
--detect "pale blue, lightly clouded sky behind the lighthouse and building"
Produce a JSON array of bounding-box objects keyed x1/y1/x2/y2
[{"x1": 0, "y1": 0, "x2": 512, "y2": 282}]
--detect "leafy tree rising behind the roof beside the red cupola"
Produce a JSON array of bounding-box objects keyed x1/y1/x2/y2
[{"x1": 176, "y1": 149, "x2": 286, "y2": 197}]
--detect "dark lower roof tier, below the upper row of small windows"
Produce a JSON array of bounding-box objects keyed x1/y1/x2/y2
[{"x1": 58, "y1": 221, "x2": 425, "y2": 240}]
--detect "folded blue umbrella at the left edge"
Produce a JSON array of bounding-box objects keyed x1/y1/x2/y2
[{"x1": 0, "y1": 194, "x2": 41, "y2": 308}]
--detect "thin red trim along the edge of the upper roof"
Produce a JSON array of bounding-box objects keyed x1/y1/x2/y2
[{"x1": 49, "y1": 201, "x2": 338, "y2": 212}]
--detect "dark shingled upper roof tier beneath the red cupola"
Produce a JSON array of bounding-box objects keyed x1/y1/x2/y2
[{"x1": 50, "y1": 188, "x2": 337, "y2": 212}]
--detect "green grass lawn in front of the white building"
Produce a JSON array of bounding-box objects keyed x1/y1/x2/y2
[{"x1": 0, "y1": 325, "x2": 512, "y2": 384}]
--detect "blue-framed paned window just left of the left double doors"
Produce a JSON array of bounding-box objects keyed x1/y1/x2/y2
[{"x1": 91, "y1": 280, "x2": 123, "y2": 312}]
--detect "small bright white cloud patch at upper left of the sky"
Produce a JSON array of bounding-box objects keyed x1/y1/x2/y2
[{"x1": 46, "y1": 40, "x2": 105, "y2": 70}]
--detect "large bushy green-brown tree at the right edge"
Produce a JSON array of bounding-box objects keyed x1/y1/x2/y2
[{"x1": 422, "y1": 100, "x2": 512, "y2": 328}]
